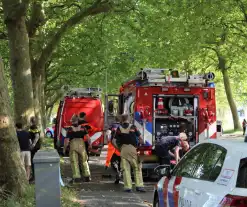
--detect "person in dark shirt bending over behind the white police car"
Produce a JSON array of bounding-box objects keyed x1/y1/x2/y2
[{"x1": 155, "y1": 125, "x2": 189, "y2": 165}]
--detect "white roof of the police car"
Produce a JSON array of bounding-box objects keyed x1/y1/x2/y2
[{"x1": 201, "y1": 138, "x2": 247, "y2": 156}]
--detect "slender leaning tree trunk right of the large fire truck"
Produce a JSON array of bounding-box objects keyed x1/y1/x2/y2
[{"x1": 221, "y1": 69, "x2": 241, "y2": 130}]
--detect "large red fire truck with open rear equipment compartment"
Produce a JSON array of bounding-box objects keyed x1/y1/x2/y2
[{"x1": 105, "y1": 69, "x2": 216, "y2": 175}]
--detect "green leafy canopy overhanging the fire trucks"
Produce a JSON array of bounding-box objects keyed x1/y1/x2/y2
[{"x1": 0, "y1": 0, "x2": 247, "y2": 121}]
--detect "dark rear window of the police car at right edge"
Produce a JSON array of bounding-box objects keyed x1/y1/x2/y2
[{"x1": 236, "y1": 157, "x2": 247, "y2": 188}]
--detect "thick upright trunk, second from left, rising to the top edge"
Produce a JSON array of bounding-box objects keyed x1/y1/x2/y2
[{"x1": 3, "y1": 0, "x2": 34, "y2": 125}]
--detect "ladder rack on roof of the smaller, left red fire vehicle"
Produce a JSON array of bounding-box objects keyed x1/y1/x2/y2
[{"x1": 62, "y1": 86, "x2": 102, "y2": 98}]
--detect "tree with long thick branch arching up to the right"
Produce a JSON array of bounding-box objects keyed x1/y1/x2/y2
[{"x1": 29, "y1": 0, "x2": 112, "y2": 131}]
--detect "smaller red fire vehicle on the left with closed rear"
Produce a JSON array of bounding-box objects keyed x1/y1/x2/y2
[{"x1": 54, "y1": 86, "x2": 104, "y2": 154}]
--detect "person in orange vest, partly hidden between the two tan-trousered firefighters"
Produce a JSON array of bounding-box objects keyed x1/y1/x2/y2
[{"x1": 105, "y1": 117, "x2": 121, "y2": 184}]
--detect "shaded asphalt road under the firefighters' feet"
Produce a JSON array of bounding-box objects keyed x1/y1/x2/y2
[{"x1": 62, "y1": 152, "x2": 156, "y2": 207}]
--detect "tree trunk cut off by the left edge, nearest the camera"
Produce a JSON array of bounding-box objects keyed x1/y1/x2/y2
[{"x1": 0, "y1": 57, "x2": 27, "y2": 196}]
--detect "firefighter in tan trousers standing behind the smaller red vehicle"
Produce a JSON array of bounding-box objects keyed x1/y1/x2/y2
[{"x1": 64, "y1": 115, "x2": 90, "y2": 183}]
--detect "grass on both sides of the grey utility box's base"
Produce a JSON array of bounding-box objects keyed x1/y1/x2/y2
[{"x1": 0, "y1": 185, "x2": 82, "y2": 207}]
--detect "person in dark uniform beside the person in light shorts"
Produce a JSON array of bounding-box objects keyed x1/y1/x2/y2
[{"x1": 28, "y1": 117, "x2": 41, "y2": 181}]
